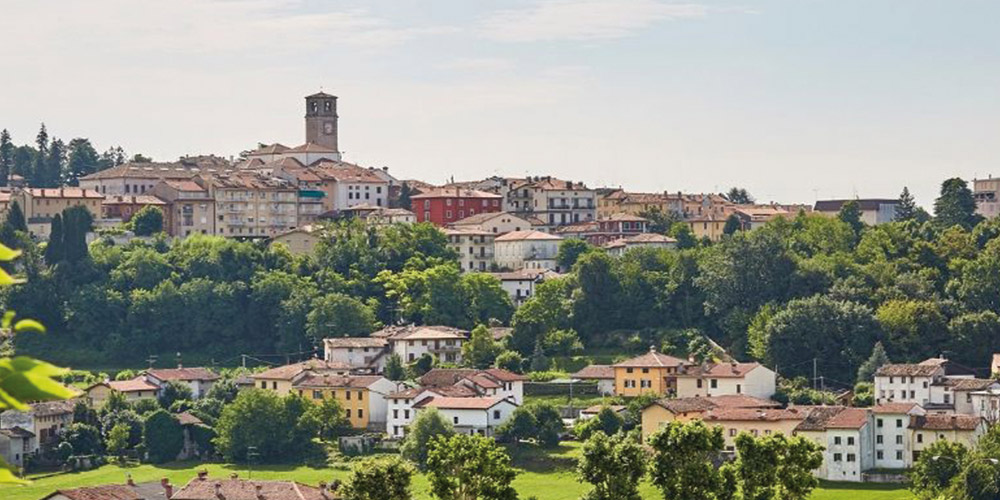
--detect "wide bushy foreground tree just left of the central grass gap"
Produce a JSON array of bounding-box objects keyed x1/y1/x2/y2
[{"x1": 427, "y1": 434, "x2": 517, "y2": 500}]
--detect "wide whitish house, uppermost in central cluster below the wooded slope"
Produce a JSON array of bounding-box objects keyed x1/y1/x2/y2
[{"x1": 371, "y1": 325, "x2": 469, "y2": 363}]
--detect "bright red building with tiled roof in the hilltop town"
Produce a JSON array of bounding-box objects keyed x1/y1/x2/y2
[{"x1": 410, "y1": 187, "x2": 503, "y2": 227}]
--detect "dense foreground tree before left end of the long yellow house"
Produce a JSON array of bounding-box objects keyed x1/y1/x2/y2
[{"x1": 649, "y1": 420, "x2": 725, "y2": 500}]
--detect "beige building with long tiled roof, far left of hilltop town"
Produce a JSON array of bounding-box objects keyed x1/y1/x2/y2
[{"x1": 13, "y1": 187, "x2": 104, "y2": 239}]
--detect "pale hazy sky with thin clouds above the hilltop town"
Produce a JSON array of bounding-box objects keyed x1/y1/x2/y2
[{"x1": 0, "y1": 0, "x2": 1000, "y2": 204}]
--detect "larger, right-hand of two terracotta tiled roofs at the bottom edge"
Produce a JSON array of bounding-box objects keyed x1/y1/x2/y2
[{"x1": 171, "y1": 477, "x2": 335, "y2": 500}]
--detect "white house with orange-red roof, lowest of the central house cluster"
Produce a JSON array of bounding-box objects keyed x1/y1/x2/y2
[{"x1": 413, "y1": 396, "x2": 518, "y2": 436}]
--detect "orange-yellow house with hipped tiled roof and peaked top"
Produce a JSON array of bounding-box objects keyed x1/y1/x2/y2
[{"x1": 613, "y1": 346, "x2": 691, "y2": 397}]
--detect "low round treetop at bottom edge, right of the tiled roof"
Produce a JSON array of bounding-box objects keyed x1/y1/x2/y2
[{"x1": 344, "y1": 458, "x2": 413, "y2": 500}]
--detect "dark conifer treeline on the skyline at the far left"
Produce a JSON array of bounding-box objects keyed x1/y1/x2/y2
[{"x1": 0, "y1": 123, "x2": 134, "y2": 188}]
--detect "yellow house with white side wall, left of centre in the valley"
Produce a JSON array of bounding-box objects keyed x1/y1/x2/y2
[{"x1": 292, "y1": 372, "x2": 398, "y2": 431}]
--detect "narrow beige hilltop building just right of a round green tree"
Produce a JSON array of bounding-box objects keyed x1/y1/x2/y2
[{"x1": 151, "y1": 179, "x2": 215, "y2": 237}]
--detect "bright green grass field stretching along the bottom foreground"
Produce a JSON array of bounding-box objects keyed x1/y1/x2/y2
[{"x1": 0, "y1": 443, "x2": 913, "y2": 500}]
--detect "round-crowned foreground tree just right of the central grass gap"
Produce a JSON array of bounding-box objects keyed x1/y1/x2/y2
[{"x1": 577, "y1": 432, "x2": 646, "y2": 500}]
